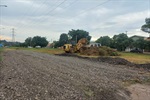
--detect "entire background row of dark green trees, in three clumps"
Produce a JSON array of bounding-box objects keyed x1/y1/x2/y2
[{"x1": 21, "y1": 29, "x2": 150, "y2": 51}]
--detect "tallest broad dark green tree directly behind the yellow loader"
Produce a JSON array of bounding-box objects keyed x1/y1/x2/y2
[{"x1": 68, "y1": 29, "x2": 91, "y2": 43}]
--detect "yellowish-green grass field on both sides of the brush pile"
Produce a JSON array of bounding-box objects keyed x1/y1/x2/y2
[{"x1": 6, "y1": 47, "x2": 150, "y2": 64}]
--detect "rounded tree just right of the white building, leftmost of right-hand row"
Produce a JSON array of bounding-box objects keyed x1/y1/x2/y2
[{"x1": 96, "y1": 36, "x2": 112, "y2": 47}]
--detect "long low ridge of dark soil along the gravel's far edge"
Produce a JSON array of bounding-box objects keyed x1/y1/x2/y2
[{"x1": 56, "y1": 53, "x2": 150, "y2": 71}]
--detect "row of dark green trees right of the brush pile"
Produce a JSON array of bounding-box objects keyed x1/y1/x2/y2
[{"x1": 96, "y1": 33, "x2": 150, "y2": 51}]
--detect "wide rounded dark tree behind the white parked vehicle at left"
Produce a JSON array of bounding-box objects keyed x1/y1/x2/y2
[{"x1": 31, "y1": 36, "x2": 48, "y2": 47}]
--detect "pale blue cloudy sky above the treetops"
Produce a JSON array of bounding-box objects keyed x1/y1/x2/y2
[{"x1": 0, "y1": 0, "x2": 150, "y2": 42}]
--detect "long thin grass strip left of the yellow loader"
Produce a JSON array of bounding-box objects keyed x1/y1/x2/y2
[{"x1": 7, "y1": 47, "x2": 64, "y2": 54}]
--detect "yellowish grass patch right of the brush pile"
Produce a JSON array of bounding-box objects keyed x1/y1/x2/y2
[{"x1": 119, "y1": 52, "x2": 150, "y2": 64}]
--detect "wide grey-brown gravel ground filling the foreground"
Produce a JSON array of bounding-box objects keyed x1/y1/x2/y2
[{"x1": 0, "y1": 50, "x2": 150, "y2": 100}]
